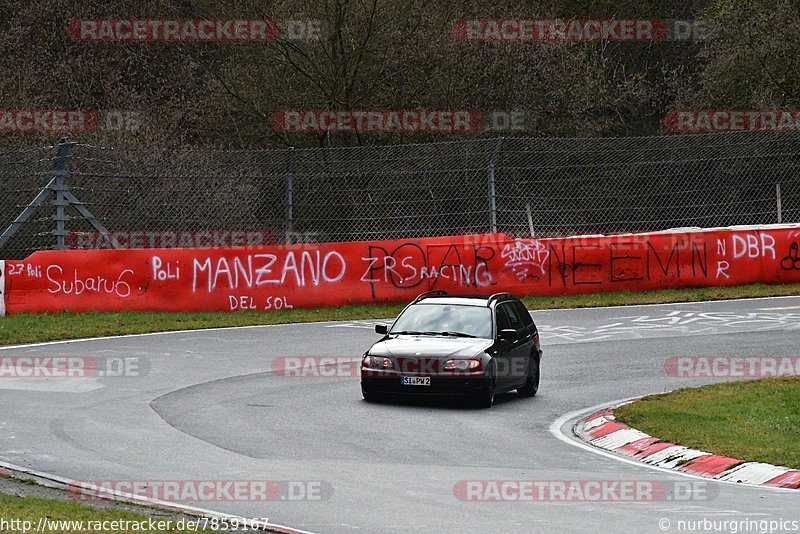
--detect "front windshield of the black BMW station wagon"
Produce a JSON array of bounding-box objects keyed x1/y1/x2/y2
[{"x1": 391, "y1": 303, "x2": 492, "y2": 339}]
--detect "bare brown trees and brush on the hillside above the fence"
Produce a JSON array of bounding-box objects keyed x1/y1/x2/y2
[{"x1": 0, "y1": 0, "x2": 800, "y2": 148}]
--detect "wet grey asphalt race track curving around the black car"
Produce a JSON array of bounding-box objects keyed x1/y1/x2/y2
[{"x1": 0, "y1": 297, "x2": 800, "y2": 533}]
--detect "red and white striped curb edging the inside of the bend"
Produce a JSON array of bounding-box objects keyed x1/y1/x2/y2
[{"x1": 574, "y1": 408, "x2": 800, "y2": 489}]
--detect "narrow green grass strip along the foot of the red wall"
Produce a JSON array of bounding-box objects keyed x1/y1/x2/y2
[{"x1": 0, "y1": 284, "x2": 800, "y2": 345}]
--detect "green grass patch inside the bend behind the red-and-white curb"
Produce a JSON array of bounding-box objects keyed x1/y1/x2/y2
[{"x1": 614, "y1": 376, "x2": 800, "y2": 469}]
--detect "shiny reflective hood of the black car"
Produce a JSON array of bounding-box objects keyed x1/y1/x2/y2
[{"x1": 369, "y1": 335, "x2": 493, "y2": 358}]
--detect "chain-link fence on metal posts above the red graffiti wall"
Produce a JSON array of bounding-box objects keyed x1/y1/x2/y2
[{"x1": 0, "y1": 132, "x2": 800, "y2": 259}]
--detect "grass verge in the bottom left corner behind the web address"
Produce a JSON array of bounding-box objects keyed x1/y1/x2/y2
[{"x1": 0, "y1": 493, "x2": 208, "y2": 534}]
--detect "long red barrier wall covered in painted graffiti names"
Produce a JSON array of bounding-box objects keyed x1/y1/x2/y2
[{"x1": 0, "y1": 226, "x2": 800, "y2": 314}]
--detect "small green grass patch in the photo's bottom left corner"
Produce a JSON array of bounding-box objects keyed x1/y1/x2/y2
[{"x1": 0, "y1": 494, "x2": 209, "y2": 534}]
